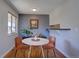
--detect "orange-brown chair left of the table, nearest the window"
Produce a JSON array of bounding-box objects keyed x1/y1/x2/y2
[{"x1": 15, "y1": 37, "x2": 28, "y2": 57}]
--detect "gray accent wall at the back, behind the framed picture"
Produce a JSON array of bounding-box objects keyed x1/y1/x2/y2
[{"x1": 19, "y1": 14, "x2": 49, "y2": 36}]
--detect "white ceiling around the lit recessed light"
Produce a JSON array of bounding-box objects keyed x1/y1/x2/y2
[{"x1": 9, "y1": 0, "x2": 65, "y2": 14}]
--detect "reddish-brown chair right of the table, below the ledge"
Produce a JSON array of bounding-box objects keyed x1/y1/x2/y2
[{"x1": 43, "y1": 36, "x2": 56, "y2": 57}]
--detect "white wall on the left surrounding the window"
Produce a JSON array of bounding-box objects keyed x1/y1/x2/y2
[{"x1": 0, "y1": 0, "x2": 18, "y2": 57}]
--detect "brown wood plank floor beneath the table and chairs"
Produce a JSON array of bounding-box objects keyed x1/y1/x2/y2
[{"x1": 4, "y1": 47, "x2": 65, "y2": 58}]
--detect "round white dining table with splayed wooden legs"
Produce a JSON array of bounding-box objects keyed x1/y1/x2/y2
[{"x1": 22, "y1": 38, "x2": 49, "y2": 57}]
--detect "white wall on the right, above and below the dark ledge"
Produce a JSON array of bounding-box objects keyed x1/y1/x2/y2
[{"x1": 50, "y1": 0, "x2": 79, "y2": 57}]
